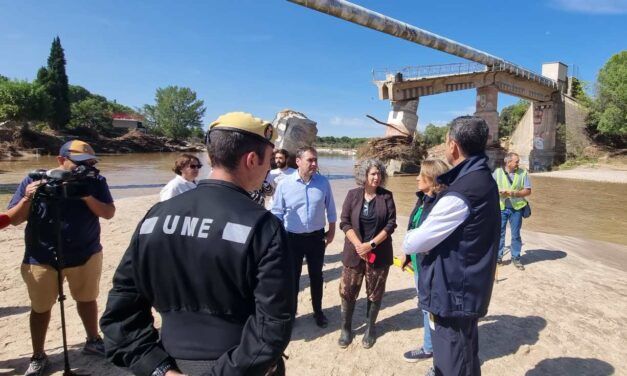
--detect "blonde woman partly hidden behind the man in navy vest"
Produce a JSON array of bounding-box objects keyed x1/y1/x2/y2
[{"x1": 402, "y1": 159, "x2": 449, "y2": 363}]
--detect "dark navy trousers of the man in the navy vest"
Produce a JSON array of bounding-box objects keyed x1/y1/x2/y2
[{"x1": 431, "y1": 316, "x2": 481, "y2": 376}]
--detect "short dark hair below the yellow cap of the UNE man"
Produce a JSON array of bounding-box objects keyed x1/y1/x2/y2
[{"x1": 207, "y1": 129, "x2": 269, "y2": 171}]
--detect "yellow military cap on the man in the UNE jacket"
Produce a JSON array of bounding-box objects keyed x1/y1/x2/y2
[{"x1": 207, "y1": 112, "x2": 276, "y2": 146}]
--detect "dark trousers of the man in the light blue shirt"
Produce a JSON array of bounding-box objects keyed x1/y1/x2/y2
[{"x1": 287, "y1": 229, "x2": 326, "y2": 313}]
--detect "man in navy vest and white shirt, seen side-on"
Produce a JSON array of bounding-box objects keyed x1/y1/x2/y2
[{"x1": 403, "y1": 116, "x2": 501, "y2": 376}]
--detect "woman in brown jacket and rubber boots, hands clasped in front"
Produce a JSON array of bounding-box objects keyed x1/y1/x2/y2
[{"x1": 338, "y1": 159, "x2": 396, "y2": 349}]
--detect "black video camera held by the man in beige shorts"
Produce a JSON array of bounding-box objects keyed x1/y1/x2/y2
[{"x1": 28, "y1": 165, "x2": 100, "y2": 199}]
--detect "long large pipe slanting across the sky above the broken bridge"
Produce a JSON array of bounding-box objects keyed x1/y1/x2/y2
[{"x1": 288, "y1": 0, "x2": 557, "y2": 89}]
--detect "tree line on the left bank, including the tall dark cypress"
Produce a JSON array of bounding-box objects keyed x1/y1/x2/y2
[{"x1": 0, "y1": 36, "x2": 205, "y2": 139}]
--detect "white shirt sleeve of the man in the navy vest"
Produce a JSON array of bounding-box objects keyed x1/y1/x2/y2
[{"x1": 403, "y1": 194, "x2": 470, "y2": 255}]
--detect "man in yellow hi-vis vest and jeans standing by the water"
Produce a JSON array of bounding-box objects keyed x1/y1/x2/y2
[{"x1": 492, "y1": 153, "x2": 531, "y2": 270}]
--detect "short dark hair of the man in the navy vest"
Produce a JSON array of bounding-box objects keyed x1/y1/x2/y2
[{"x1": 448, "y1": 116, "x2": 489, "y2": 157}]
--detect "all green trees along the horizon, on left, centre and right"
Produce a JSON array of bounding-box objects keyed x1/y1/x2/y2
[{"x1": 0, "y1": 36, "x2": 627, "y2": 145}]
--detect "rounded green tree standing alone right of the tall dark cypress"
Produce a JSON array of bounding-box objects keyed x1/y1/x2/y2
[{"x1": 142, "y1": 86, "x2": 205, "y2": 138}]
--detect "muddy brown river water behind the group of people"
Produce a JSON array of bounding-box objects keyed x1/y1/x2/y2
[{"x1": 0, "y1": 153, "x2": 627, "y2": 244}]
